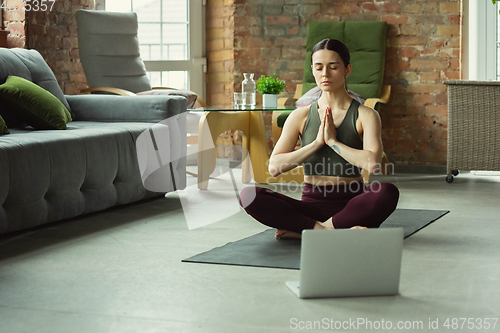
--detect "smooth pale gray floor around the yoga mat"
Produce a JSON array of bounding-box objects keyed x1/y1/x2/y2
[{"x1": 0, "y1": 173, "x2": 500, "y2": 333}]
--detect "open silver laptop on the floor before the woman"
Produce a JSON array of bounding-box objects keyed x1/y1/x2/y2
[{"x1": 286, "y1": 228, "x2": 404, "y2": 298}]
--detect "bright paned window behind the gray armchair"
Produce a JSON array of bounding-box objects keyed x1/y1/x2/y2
[{"x1": 96, "y1": 0, "x2": 206, "y2": 99}]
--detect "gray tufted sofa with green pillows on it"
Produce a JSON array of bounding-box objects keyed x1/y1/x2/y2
[{"x1": 0, "y1": 48, "x2": 187, "y2": 234}]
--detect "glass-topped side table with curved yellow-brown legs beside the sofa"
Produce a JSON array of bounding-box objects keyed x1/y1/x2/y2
[{"x1": 188, "y1": 107, "x2": 304, "y2": 190}]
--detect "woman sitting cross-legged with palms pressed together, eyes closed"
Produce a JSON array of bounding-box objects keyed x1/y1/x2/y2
[{"x1": 240, "y1": 39, "x2": 399, "y2": 238}]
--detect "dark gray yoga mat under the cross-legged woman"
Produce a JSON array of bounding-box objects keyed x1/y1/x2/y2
[{"x1": 182, "y1": 209, "x2": 449, "y2": 269}]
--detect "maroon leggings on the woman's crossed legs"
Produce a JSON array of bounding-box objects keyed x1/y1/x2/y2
[{"x1": 240, "y1": 182, "x2": 399, "y2": 233}]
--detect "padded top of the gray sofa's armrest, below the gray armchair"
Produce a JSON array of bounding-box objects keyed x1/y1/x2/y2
[{"x1": 66, "y1": 95, "x2": 186, "y2": 123}]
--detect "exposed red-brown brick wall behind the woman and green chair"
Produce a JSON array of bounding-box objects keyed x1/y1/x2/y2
[{"x1": 207, "y1": 0, "x2": 462, "y2": 165}]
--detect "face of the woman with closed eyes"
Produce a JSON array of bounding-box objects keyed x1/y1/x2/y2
[{"x1": 312, "y1": 50, "x2": 351, "y2": 91}]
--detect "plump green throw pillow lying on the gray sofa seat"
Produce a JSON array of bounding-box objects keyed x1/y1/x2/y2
[{"x1": 0, "y1": 75, "x2": 71, "y2": 130}]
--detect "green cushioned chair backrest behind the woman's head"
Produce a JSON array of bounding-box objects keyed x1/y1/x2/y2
[{"x1": 302, "y1": 21, "x2": 387, "y2": 99}]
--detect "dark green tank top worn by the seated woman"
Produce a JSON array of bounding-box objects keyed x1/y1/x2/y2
[{"x1": 301, "y1": 99, "x2": 363, "y2": 178}]
